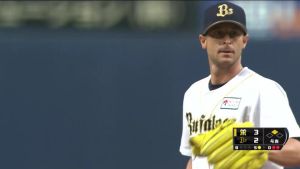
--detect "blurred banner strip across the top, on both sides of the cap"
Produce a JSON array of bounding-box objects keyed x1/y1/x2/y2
[{"x1": 0, "y1": 1, "x2": 300, "y2": 39}]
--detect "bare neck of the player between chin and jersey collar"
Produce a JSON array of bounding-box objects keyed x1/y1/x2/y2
[{"x1": 210, "y1": 65, "x2": 243, "y2": 85}]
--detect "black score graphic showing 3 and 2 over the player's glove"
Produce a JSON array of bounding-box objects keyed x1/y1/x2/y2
[{"x1": 233, "y1": 128, "x2": 289, "y2": 150}]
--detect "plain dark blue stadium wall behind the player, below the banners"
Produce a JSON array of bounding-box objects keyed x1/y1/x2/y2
[{"x1": 0, "y1": 29, "x2": 300, "y2": 169}]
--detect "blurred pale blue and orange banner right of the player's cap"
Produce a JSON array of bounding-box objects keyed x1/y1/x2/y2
[{"x1": 198, "y1": 1, "x2": 300, "y2": 39}]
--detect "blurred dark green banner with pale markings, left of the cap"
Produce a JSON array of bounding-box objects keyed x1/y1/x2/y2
[{"x1": 0, "y1": 1, "x2": 194, "y2": 31}]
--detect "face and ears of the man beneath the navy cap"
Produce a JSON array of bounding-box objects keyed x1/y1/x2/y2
[{"x1": 199, "y1": 23, "x2": 248, "y2": 68}]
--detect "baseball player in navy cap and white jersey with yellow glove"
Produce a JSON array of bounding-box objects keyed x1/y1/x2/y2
[{"x1": 180, "y1": 2, "x2": 300, "y2": 169}]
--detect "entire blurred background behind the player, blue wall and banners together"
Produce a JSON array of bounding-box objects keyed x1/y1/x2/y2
[{"x1": 0, "y1": 1, "x2": 300, "y2": 169}]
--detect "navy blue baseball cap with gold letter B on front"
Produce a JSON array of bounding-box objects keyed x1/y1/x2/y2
[{"x1": 202, "y1": 2, "x2": 247, "y2": 35}]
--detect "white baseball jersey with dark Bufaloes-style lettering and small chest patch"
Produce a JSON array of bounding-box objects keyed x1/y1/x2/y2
[{"x1": 180, "y1": 67, "x2": 300, "y2": 169}]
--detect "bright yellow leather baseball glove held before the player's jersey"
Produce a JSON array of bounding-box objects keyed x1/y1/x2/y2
[{"x1": 190, "y1": 119, "x2": 268, "y2": 169}]
